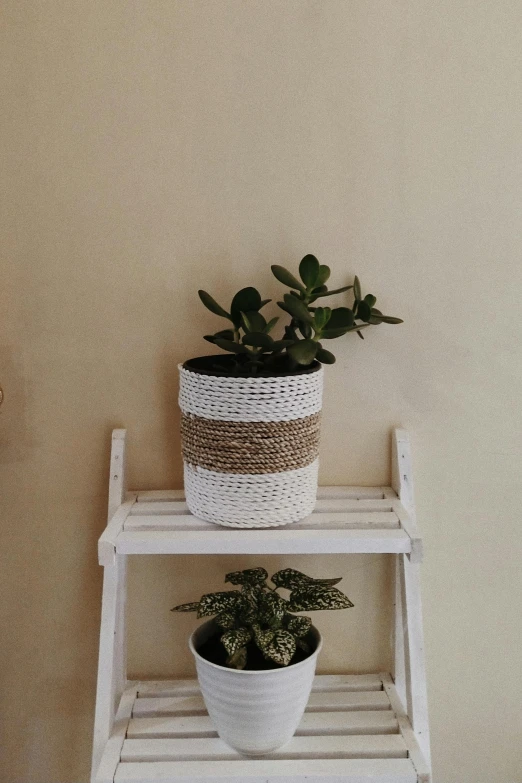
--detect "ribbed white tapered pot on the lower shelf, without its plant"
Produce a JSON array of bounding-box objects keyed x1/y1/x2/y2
[{"x1": 189, "y1": 620, "x2": 322, "y2": 756}]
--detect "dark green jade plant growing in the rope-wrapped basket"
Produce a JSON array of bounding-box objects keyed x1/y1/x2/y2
[{"x1": 198, "y1": 254, "x2": 402, "y2": 375}]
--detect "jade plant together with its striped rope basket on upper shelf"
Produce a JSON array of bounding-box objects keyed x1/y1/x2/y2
[{"x1": 179, "y1": 255, "x2": 402, "y2": 527}]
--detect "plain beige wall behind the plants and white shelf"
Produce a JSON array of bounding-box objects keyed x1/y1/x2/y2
[{"x1": 0, "y1": 0, "x2": 522, "y2": 783}]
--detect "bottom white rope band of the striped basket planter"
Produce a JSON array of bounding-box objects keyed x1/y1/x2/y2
[{"x1": 184, "y1": 460, "x2": 319, "y2": 528}]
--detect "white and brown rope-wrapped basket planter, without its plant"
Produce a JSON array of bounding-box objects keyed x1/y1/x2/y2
[{"x1": 179, "y1": 363, "x2": 323, "y2": 528}]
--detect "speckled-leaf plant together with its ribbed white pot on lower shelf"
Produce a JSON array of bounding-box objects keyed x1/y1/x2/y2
[{"x1": 172, "y1": 568, "x2": 353, "y2": 756}]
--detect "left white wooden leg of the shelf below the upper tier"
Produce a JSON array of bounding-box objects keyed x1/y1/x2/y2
[{"x1": 91, "y1": 555, "x2": 127, "y2": 780}]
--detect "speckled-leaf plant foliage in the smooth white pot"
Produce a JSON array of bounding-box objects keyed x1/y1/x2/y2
[{"x1": 172, "y1": 568, "x2": 353, "y2": 669}]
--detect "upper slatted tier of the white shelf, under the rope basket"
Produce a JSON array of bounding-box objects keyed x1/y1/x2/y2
[{"x1": 99, "y1": 487, "x2": 422, "y2": 565}]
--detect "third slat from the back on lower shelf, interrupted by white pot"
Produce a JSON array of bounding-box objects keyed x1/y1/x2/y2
[{"x1": 127, "y1": 710, "x2": 399, "y2": 739}]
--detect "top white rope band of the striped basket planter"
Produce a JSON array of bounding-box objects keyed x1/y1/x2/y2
[{"x1": 179, "y1": 365, "x2": 323, "y2": 421}]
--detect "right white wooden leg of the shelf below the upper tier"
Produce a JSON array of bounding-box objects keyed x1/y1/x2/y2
[{"x1": 400, "y1": 556, "x2": 431, "y2": 764}]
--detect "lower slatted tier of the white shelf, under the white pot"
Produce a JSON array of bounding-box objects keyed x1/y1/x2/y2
[{"x1": 94, "y1": 674, "x2": 429, "y2": 783}]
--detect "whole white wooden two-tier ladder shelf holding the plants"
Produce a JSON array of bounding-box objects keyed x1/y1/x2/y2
[{"x1": 91, "y1": 430, "x2": 431, "y2": 783}]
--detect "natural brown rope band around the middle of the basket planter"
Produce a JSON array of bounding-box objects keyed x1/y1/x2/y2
[{"x1": 181, "y1": 413, "x2": 321, "y2": 473}]
